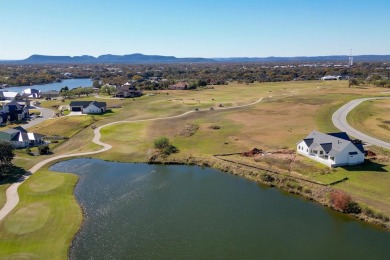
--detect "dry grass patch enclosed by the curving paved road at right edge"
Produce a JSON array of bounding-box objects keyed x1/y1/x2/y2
[{"x1": 347, "y1": 99, "x2": 390, "y2": 142}]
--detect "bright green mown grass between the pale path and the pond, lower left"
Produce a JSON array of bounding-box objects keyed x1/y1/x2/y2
[{"x1": 0, "y1": 169, "x2": 82, "y2": 259}]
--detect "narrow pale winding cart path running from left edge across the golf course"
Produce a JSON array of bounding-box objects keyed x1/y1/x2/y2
[{"x1": 0, "y1": 98, "x2": 263, "y2": 221}]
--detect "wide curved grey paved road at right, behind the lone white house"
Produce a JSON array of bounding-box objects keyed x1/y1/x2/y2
[{"x1": 332, "y1": 97, "x2": 390, "y2": 149}]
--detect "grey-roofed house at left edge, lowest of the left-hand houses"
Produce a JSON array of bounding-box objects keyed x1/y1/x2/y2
[{"x1": 0, "y1": 126, "x2": 44, "y2": 148}]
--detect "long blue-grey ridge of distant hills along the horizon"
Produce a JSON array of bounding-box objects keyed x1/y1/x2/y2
[{"x1": 0, "y1": 53, "x2": 390, "y2": 64}]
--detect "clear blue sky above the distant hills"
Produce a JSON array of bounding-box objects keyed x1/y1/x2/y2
[{"x1": 0, "y1": 0, "x2": 390, "y2": 60}]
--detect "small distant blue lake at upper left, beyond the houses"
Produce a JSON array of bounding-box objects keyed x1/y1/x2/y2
[{"x1": 0, "y1": 79, "x2": 92, "y2": 93}]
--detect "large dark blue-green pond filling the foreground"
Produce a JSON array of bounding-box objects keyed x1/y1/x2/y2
[{"x1": 50, "y1": 159, "x2": 390, "y2": 259}]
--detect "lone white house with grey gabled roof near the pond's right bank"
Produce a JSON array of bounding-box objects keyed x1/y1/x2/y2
[{"x1": 297, "y1": 131, "x2": 365, "y2": 167}]
